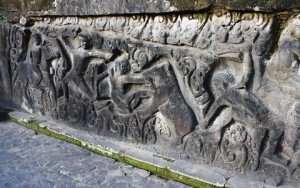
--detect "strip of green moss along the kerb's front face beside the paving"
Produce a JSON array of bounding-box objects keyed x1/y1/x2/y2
[{"x1": 9, "y1": 116, "x2": 220, "y2": 188}]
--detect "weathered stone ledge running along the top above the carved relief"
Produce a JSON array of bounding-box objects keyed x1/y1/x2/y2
[{"x1": 0, "y1": 0, "x2": 300, "y2": 22}]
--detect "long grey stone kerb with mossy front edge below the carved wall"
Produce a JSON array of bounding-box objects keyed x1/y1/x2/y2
[{"x1": 0, "y1": 110, "x2": 270, "y2": 188}]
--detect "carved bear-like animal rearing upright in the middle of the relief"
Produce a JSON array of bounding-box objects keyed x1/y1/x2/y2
[{"x1": 137, "y1": 62, "x2": 197, "y2": 147}]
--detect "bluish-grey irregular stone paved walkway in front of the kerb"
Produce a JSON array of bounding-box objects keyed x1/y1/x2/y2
[{"x1": 0, "y1": 122, "x2": 188, "y2": 188}]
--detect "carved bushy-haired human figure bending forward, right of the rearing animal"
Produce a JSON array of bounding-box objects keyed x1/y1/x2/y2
[{"x1": 203, "y1": 73, "x2": 287, "y2": 167}]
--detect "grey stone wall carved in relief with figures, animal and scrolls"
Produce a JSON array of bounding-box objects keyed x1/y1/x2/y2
[{"x1": 0, "y1": 11, "x2": 300, "y2": 185}]
